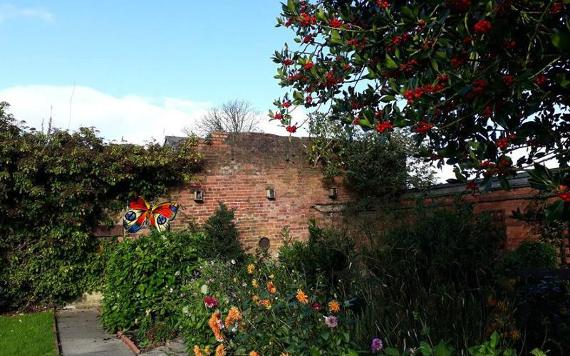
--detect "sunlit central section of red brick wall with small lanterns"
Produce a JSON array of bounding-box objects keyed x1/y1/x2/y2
[{"x1": 165, "y1": 133, "x2": 349, "y2": 251}]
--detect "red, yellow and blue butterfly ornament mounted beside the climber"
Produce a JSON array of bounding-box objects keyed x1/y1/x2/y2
[{"x1": 123, "y1": 197, "x2": 178, "y2": 233}]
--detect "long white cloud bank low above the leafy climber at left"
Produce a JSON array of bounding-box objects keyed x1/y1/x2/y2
[{"x1": 0, "y1": 85, "x2": 210, "y2": 143}]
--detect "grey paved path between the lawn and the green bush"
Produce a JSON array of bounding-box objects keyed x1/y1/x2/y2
[{"x1": 56, "y1": 309, "x2": 133, "y2": 356}]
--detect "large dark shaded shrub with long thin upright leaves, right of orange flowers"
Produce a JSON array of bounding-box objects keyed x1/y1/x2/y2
[{"x1": 351, "y1": 205, "x2": 504, "y2": 350}]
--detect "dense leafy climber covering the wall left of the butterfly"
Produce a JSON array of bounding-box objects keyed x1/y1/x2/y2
[{"x1": 0, "y1": 103, "x2": 200, "y2": 310}]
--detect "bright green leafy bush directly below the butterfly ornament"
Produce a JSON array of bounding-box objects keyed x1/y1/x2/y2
[{"x1": 102, "y1": 228, "x2": 204, "y2": 346}]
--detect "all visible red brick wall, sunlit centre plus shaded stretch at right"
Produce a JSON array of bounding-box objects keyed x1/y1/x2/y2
[{"x1": 99, "y1": 133, "x2": 535, "y2": 252}]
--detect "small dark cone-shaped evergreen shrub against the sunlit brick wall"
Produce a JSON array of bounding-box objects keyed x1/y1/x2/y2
[{"x1": 203, "y1": 203, "x2": 243, "y2": 261}]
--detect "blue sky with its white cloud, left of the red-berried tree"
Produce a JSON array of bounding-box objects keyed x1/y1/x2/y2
[{"x1": 0, "y1": 0, "x2": 292, "y2": 142}]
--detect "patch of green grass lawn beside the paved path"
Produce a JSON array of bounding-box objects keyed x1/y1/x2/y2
[{"x1": 0, "y1": 311, "x2": 57, "y2": 356}]
